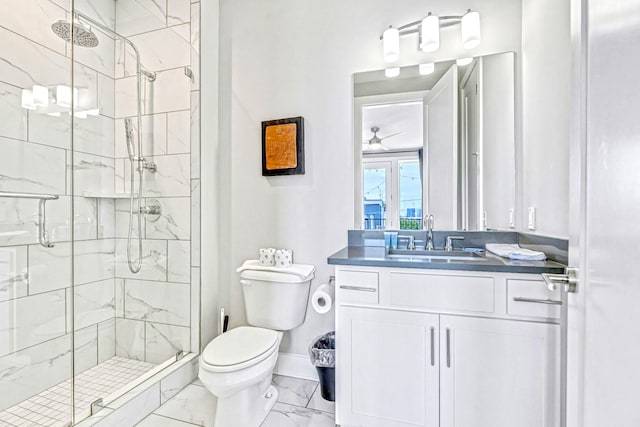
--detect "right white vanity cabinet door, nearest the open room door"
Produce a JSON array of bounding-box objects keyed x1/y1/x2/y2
[{"x1": 440, "y1": 316, "x2": 560, "y2": 427}]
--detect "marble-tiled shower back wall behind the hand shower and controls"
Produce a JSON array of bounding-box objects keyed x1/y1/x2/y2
[{"x1": 114, "y1": 0, "x2": 200, "y2": 363}]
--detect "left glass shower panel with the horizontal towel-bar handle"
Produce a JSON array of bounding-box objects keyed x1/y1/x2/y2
[{"x1": 0, "y1": 0, "x2": 73, "y2": 426}]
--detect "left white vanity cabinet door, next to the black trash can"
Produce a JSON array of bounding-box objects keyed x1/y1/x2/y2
[{"x1": 336, "y1": 307, "x2": 439, "y2": 427}]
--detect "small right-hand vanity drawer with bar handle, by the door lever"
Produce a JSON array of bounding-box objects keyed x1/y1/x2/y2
[{"x1": 507, "y1": 279, "x2": 560, "y2": 319}]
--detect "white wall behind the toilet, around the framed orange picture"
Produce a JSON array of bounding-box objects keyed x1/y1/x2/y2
[{"x1": 212, "y1": 0, "x2": 521, "y2": 354}]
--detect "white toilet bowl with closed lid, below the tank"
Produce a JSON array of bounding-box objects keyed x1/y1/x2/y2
[{"x1": 198, "y1": 326, "x2": 282, "y2": 427}]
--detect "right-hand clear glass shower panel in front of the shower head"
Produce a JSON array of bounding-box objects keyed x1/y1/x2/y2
[{"x1": 67, "y1": 0, "x2": 199, "y2": 422}]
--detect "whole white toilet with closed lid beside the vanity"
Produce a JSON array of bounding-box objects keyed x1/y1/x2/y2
[{"x1": 198, "y1": 261, "x2": 315, "y2": 427}]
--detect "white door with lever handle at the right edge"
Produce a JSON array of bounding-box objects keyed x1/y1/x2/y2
[{"x1": 568, "y1": 0, "x2": 640, "y2": 427}]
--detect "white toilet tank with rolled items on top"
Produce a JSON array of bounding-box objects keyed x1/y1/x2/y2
[{"x1": 238, "y1": 263, "x2": 315, "y2": 331}]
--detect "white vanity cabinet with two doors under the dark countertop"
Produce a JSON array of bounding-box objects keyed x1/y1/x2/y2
[{"x1": 336, "y1": 266, "x2": 560, "y2": 427}]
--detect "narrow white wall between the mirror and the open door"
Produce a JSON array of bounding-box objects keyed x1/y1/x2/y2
[{"x1": 521, "y1": 0, "x2": 571, "y2": 238}]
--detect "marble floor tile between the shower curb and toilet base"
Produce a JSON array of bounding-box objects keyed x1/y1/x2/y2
[{"x1": 154, "y1": 384, "x2": 216, "y2": 427}]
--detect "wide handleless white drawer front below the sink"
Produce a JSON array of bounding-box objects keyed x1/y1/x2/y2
[{"x1": 390, "y1": 273, "x2": 495, "y2": 313}]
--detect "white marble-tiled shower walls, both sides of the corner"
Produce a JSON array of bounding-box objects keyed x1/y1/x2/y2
[{"x1": 0, "y1": 0, "x2": 200, "y2": 409}]
